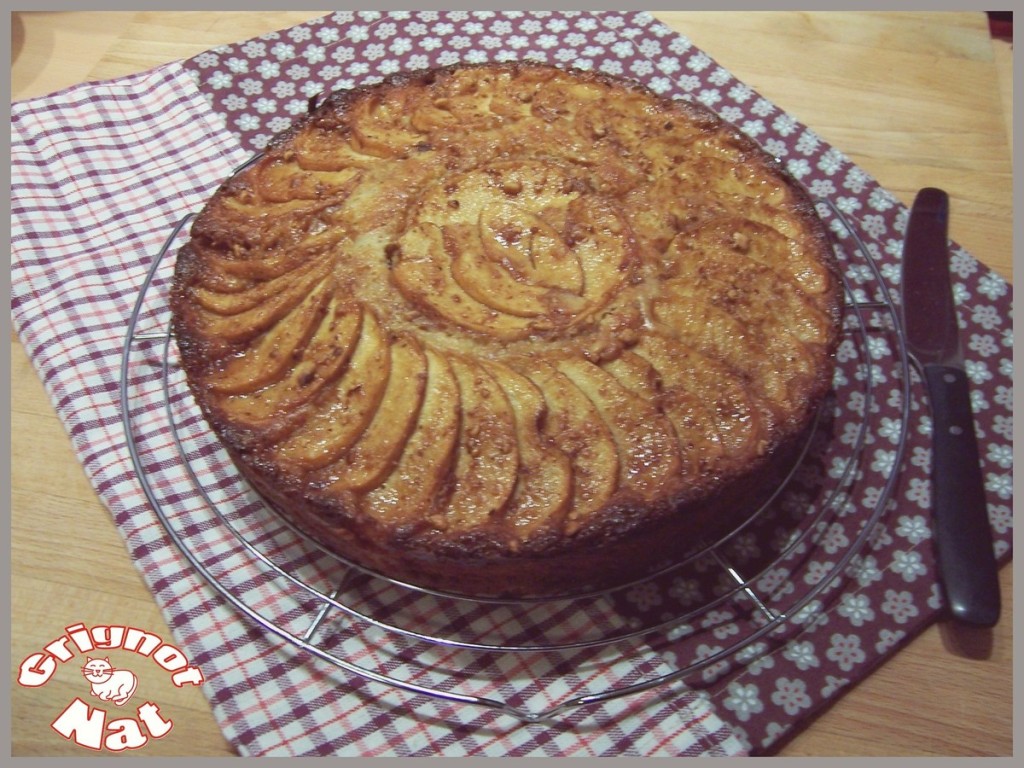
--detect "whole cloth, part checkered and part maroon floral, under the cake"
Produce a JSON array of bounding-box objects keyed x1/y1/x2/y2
[{"x1": 11, "y1": 11, "x2": 1013, "y2": 756}]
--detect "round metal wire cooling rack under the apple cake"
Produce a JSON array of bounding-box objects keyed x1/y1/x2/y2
[{"x1": 121, "y1": 195, "x2": 910, "y2": 722}]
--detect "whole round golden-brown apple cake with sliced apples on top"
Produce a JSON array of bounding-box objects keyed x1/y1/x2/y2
[{"x1": 171, "y1": 62, "x2": 842, "y2": 598}]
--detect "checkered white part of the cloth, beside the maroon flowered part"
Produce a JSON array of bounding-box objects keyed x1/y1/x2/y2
[{"x1": 11, "y1": 65, "x2": 744, "y2": 756}]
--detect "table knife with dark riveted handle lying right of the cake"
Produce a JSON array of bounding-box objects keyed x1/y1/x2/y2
[{"x1": 902, "y1": 187, "x2": 1000, "y2": 627}]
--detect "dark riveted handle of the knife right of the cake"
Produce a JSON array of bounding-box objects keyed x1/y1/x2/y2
[{"x1": 924, "y1": 365, "x2": 1000, "y2": 627}]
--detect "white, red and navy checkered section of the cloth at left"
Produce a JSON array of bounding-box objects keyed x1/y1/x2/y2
[{"x1": 11, "y1": 63, "x2": 743, "y2": 756}]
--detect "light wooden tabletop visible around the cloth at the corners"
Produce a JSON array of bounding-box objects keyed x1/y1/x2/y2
[{"x1": 10, "y1": 11, "x2": 1013, "y2": 756}]
